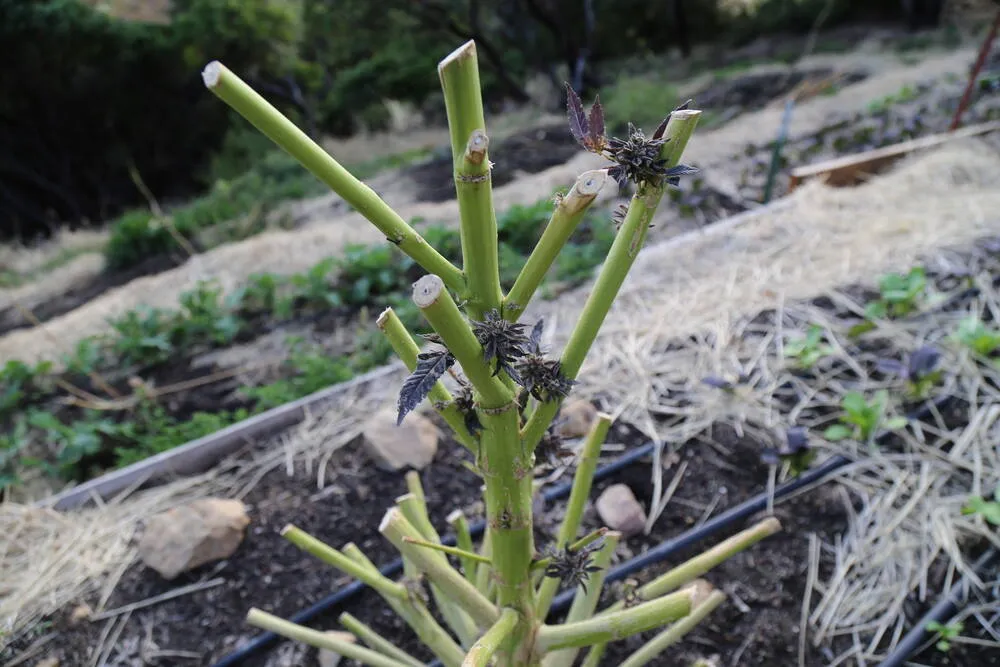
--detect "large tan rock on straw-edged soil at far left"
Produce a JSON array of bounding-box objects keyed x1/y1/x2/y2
[{"x1": 139, "y1": 498, "x2": 250, "y2": 579}]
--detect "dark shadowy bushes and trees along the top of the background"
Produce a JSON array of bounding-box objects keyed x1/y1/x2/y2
[{"x1": 0, "y1": 0, "x2": 940, "y2": 246}]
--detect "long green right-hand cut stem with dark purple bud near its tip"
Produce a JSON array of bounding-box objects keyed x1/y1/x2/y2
[{"x1": 522, "y1": 110, "x2": 701, "y2": 451}]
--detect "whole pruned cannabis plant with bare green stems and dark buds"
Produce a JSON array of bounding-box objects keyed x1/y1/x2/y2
[{"x1": 203, "y1": 42, "x2": 780, "y2": 667}]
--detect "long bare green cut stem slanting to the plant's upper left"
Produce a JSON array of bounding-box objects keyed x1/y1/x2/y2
[{"x1": 202, "y1": 61, "x2": 466, "y2": 293}]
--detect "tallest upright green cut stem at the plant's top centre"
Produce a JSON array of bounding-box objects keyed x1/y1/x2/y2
[{"x1": 438, "y1": 41, "x2": 503, "y2": 320}]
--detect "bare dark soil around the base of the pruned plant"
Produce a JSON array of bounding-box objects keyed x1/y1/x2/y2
[{"x1": 9, "y1": 414, "x2": 844, "y2": 667}]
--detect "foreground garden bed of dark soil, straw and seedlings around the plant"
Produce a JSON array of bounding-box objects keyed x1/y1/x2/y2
[{"x1": 11, "y1": 231, "x2": 1000, "y2": 667}]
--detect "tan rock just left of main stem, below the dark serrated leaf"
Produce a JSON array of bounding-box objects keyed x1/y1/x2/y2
[{"x1": 363, "y1": 408, "x2": 439, "y2": 471}]
